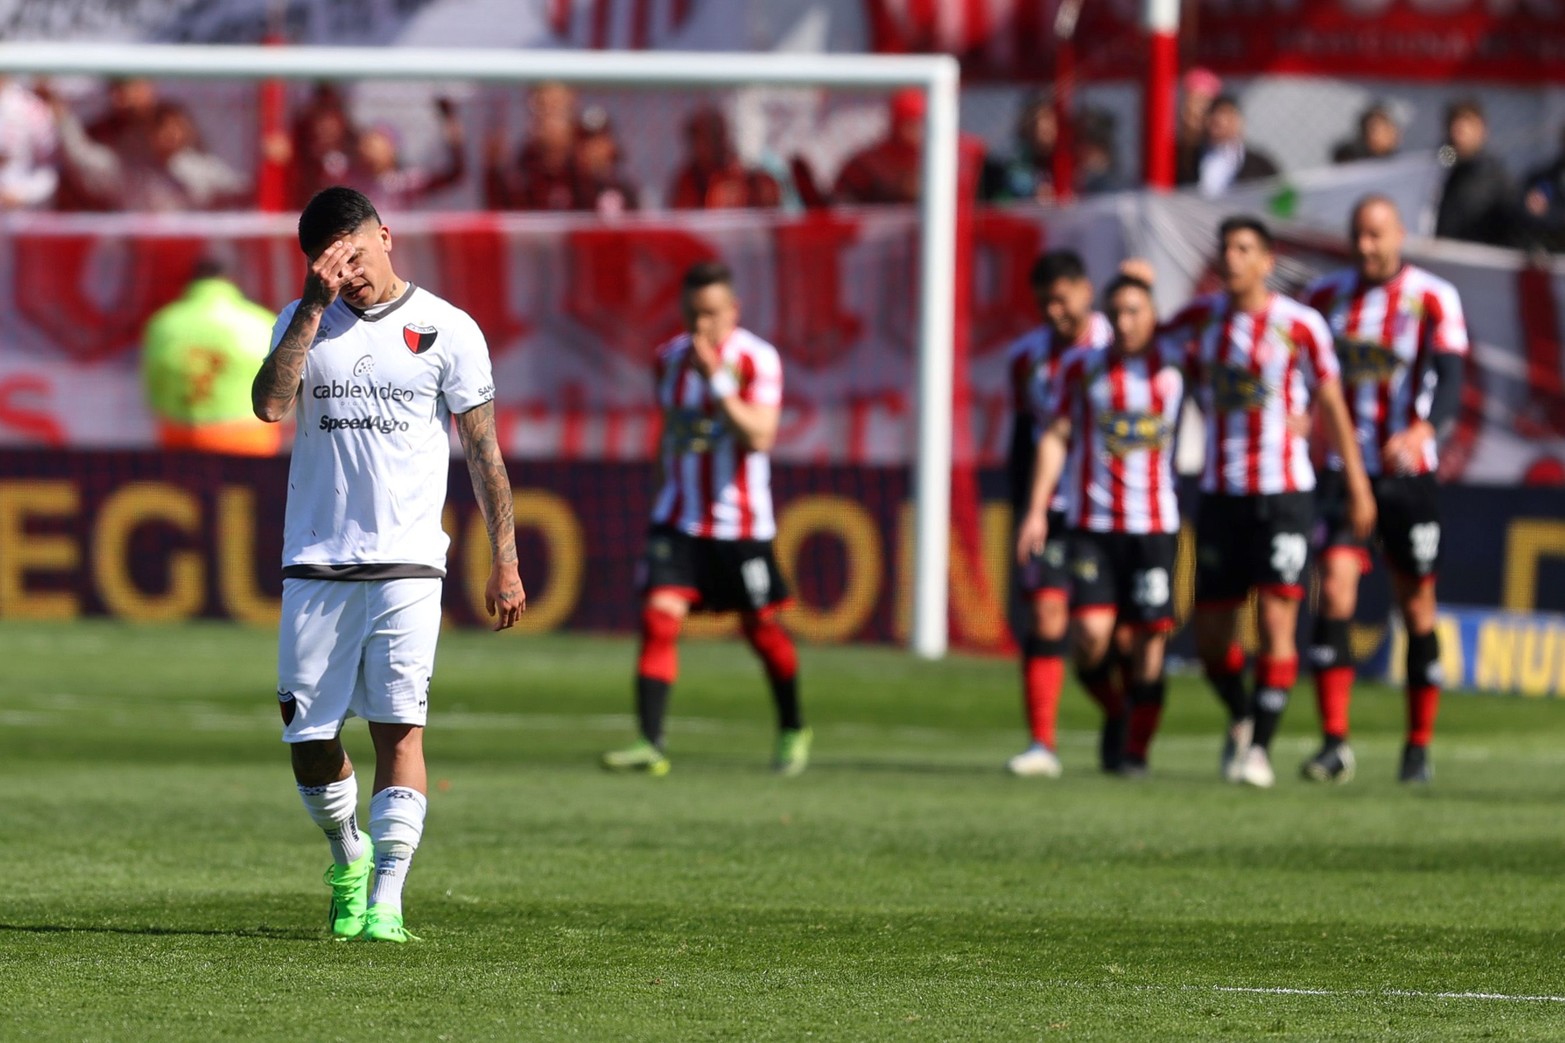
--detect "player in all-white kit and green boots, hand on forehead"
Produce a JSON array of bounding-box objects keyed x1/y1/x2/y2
[{"x1": 250, "y1": 186, "x2": 527, "y2": 943}]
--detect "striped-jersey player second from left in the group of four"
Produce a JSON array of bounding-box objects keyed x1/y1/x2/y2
[{"x1": 1016, "y1": 274, "x2": 1185, "y2": 775}]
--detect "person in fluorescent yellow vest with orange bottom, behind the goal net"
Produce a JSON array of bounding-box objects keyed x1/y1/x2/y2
[{"x1": 141, "y1": 262, "x2": 282, "y2": 456}]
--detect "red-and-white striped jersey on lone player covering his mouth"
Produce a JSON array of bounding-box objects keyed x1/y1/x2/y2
[{"x1": 653, "y1": 329, "x2": 783, "y2": 540}]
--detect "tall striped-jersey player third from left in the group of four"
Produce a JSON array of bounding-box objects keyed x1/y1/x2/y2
[{"x1": 1164, "y1": 216, "x2": 1374, "y2": 788}]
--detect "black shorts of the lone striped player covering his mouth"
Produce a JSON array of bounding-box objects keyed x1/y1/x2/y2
[{"x1": 637, "y1": 525, "x2": 789, "y2": 612}]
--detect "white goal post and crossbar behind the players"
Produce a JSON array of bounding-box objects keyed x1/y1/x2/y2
[{"x1": 0, "y1": 42, "x2": 959, "y2": 659}]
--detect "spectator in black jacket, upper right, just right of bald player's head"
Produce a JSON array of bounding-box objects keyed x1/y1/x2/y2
[{"x1": 1435, "y1": 99, "x2": 1516, "y2": 246}]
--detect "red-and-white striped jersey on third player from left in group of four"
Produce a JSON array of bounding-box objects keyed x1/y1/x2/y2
[{"x1": 1163, "y1": 293, "x2": 1338, "y2": 496}]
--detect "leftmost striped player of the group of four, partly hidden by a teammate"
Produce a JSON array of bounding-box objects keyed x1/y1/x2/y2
[{"x1": 1006, "y1": 251, "x2": 1124, "y2": 778}]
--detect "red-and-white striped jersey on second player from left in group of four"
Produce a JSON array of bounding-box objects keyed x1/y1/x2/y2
[{"x1": 1049, "y1": 341, "x2": 1185, "y2": 532}]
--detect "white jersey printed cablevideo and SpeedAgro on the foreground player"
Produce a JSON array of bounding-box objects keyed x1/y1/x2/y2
[{"x1": 272, "y1": 283, "x2": 495, "y2": 578}]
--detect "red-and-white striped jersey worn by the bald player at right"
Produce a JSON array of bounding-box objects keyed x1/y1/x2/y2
[{"x1": 1304, "y1": 265, "x2": 1468, "y2": 475}]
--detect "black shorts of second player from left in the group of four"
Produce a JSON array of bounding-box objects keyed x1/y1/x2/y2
[{"x1": 1070, "y1": 529, "x2": 1178, "y2": 630}]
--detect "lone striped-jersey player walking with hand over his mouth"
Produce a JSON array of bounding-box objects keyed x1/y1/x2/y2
[{"x1": 603, "y1": 262, "x2": 811, "y2": 775}]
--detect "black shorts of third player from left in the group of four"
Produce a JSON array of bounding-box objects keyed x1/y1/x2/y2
[{"x1": 1196, "y1": 492, "x2": 1315, "y2": 605}]
